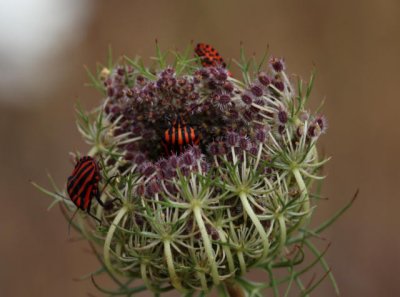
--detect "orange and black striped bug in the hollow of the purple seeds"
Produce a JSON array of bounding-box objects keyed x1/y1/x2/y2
[{"x1": 162, "y1": 114, "x2": 200, "y2": 155}]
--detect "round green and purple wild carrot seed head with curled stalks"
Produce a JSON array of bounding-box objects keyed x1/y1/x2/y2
[{"x1": 33, "y1": 44, "x2": 344, "y2": 293}]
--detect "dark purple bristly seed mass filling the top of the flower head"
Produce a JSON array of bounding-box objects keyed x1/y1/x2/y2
[{"x1": 100, "y1": 58, "x2": 326, "y2": 196}]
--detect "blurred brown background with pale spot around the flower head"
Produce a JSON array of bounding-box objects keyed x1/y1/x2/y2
[{"x1": 0, "y1": 0, "x2": 400, "y2": 297}]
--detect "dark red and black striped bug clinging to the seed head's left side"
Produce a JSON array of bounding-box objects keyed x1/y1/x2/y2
[{"x1": 67, "y1": 156, "x2": 115, "y2": 223}]
